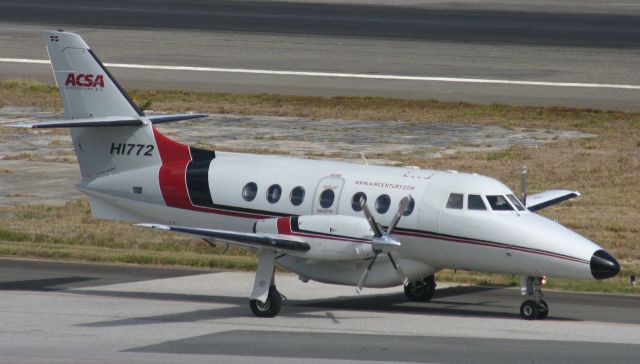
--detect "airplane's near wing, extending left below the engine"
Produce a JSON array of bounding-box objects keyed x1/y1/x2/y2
[{"x1": 136, "y1": 224, "x2": 310, "y2": 252}]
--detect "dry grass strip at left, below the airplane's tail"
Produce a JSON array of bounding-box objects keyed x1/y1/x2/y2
[{"x1": 0, "y1": 199, "x2": 256, "y2": 269}]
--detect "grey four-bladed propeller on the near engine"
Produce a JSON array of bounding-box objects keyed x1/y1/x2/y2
[{"x1": 356, "y1": 195, "x2": 413, "y2": 293}]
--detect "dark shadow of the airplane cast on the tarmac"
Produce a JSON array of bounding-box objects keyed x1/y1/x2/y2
[{"x1": 71, "y1": 286, "x2": 578, "y2": 327}]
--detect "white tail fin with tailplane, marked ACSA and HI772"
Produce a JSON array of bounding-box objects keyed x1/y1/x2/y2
[{"x1": 21, "y1": 31, "x2": 206, "y2": 181}]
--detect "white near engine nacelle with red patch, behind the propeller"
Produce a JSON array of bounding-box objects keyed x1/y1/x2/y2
[{"x1": 254, "y1": 215, "x2": 374, "y2": 260}]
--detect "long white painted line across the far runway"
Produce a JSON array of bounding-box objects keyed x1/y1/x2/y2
[{"x1": 5, "y1": 58, "x2": 640, "y2": 90}]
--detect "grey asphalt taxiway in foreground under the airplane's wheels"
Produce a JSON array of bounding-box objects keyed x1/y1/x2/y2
[{"x1": 0, "y1": 259, "x2": 640, "y2": 363}]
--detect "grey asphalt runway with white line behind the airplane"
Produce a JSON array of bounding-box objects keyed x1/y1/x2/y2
[{"x1": 0, "y1": 0, "x2": 640, "y2": 110}]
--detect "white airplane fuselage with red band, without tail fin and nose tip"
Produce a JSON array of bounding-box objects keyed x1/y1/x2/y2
[{"x1": 78, "y1": 145, "x2": 601, "y2": 287}]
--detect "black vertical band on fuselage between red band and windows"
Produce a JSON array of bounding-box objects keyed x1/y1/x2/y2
[{"x1": 186, "y1": 147, "x2": 216, "y2": 208}]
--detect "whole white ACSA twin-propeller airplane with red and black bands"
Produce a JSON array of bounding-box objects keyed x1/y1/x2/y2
[{"x1": 13, "y1": 31, "x2": 620, "y2": 320}]
